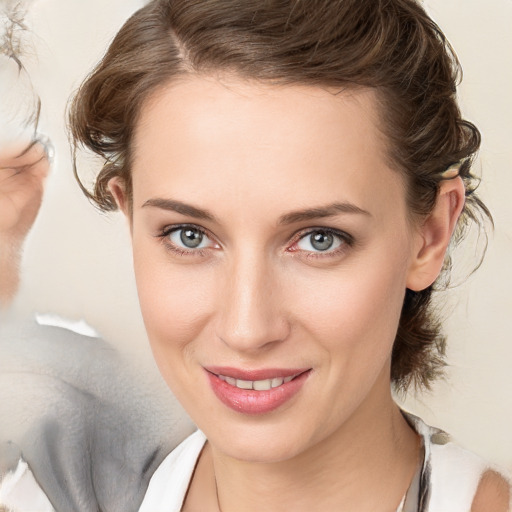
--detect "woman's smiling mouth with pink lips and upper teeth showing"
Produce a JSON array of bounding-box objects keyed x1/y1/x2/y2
[{"x1": 205, "y1": 367, "x2": 311, "y2": 414}]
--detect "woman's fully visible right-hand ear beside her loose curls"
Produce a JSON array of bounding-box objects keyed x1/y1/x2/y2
[{"x1": 407, "y1": 177, "x2": 465, "y2": 291}]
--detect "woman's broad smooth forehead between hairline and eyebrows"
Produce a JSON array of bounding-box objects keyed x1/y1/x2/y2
[{"x1": 132, "y1": 77, "x2": 403, "y2": 219}]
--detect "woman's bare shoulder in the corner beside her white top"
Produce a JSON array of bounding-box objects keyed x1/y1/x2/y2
[{"x1": 471, "y1": 470, "x2": 511, "y2": 512}]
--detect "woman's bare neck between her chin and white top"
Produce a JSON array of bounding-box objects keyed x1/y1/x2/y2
[{"x1": 207, "y1": 370, "x2": 420, "y2": 512}]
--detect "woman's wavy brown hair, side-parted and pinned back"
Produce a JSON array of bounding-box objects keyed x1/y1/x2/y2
[{"x1": 70, "y1": 0, "x2": 489, "y2": 390}]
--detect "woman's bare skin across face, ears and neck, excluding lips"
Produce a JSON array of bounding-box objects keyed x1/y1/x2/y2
[{"x1": 110, "y1": 77, "x2": 472, "y2": 512}]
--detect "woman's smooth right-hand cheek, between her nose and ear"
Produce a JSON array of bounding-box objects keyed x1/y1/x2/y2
[{"x1": 288, "y1": 247, "x2": 407, "y2": 362}]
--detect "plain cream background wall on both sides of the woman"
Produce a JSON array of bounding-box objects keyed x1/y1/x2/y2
[{"x1": 13, "y1": 0, "x2": 512, "y2": 469}]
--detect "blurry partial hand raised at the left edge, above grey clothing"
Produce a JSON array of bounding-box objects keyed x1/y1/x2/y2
[{"x1": 0, "y1": 142, "x2": 50, "y2": 308}]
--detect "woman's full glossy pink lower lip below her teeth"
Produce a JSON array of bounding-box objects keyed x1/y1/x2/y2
[{"x1": 206, "y1": 370, "x2": 311, "y2": 414}]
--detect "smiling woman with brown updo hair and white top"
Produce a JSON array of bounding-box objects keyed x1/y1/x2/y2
[{"x1": 2, "y1": 0, "x2": 509, "y2": 512}]
